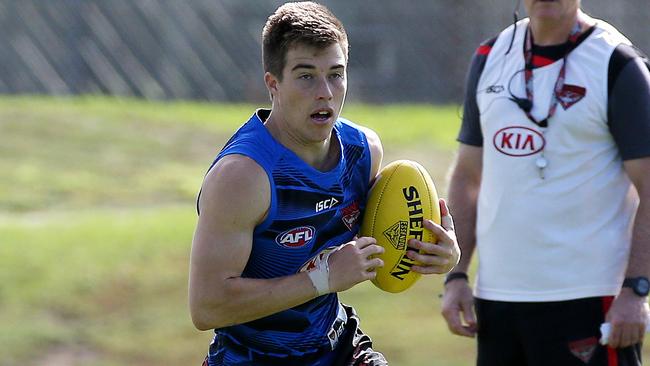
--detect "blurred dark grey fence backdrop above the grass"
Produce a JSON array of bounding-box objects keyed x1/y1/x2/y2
[{"x1": 0, "y1": 0, "x2": 650, "y2": 103}]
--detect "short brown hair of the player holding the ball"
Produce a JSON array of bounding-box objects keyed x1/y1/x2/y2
[{"x1": 262, "y1": 1, "x2": 348, "y2": 80}]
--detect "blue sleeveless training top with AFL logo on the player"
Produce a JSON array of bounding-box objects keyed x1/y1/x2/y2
[{"x1": 202, "y1": 109, "x2": 370, "y2": 364}]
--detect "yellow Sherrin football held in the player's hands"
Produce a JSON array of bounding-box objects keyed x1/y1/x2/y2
[{"x1": 359, "y1": 160, "x2": 440, "y2": 292}]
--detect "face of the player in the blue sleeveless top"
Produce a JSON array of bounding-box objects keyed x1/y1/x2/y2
[{"x1": 266, "y1": 43, "x2": 347, "y2": 143}]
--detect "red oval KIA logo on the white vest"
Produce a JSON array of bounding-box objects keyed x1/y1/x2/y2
[{"x1": 492, "y1": 126, "x2": 546, "y2": 156}]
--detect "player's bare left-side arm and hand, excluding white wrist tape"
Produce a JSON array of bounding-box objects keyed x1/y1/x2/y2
[{"x1": 189, "y1": 155, "x2": 381, "y2": 330}]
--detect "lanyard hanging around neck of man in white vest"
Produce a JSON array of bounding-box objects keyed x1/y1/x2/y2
[{"x1": 524, "y1": 20, "x2": 582, "y2": 128}]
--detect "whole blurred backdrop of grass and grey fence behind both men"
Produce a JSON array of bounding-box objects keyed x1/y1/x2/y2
[{"x1": 0, "y1": 0, "x2": 650, "y2": 366}]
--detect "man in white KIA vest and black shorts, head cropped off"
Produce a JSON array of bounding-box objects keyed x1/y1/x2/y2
[{"x1": 442, "y1": 0, "x2": 650, "y2": 366}]
